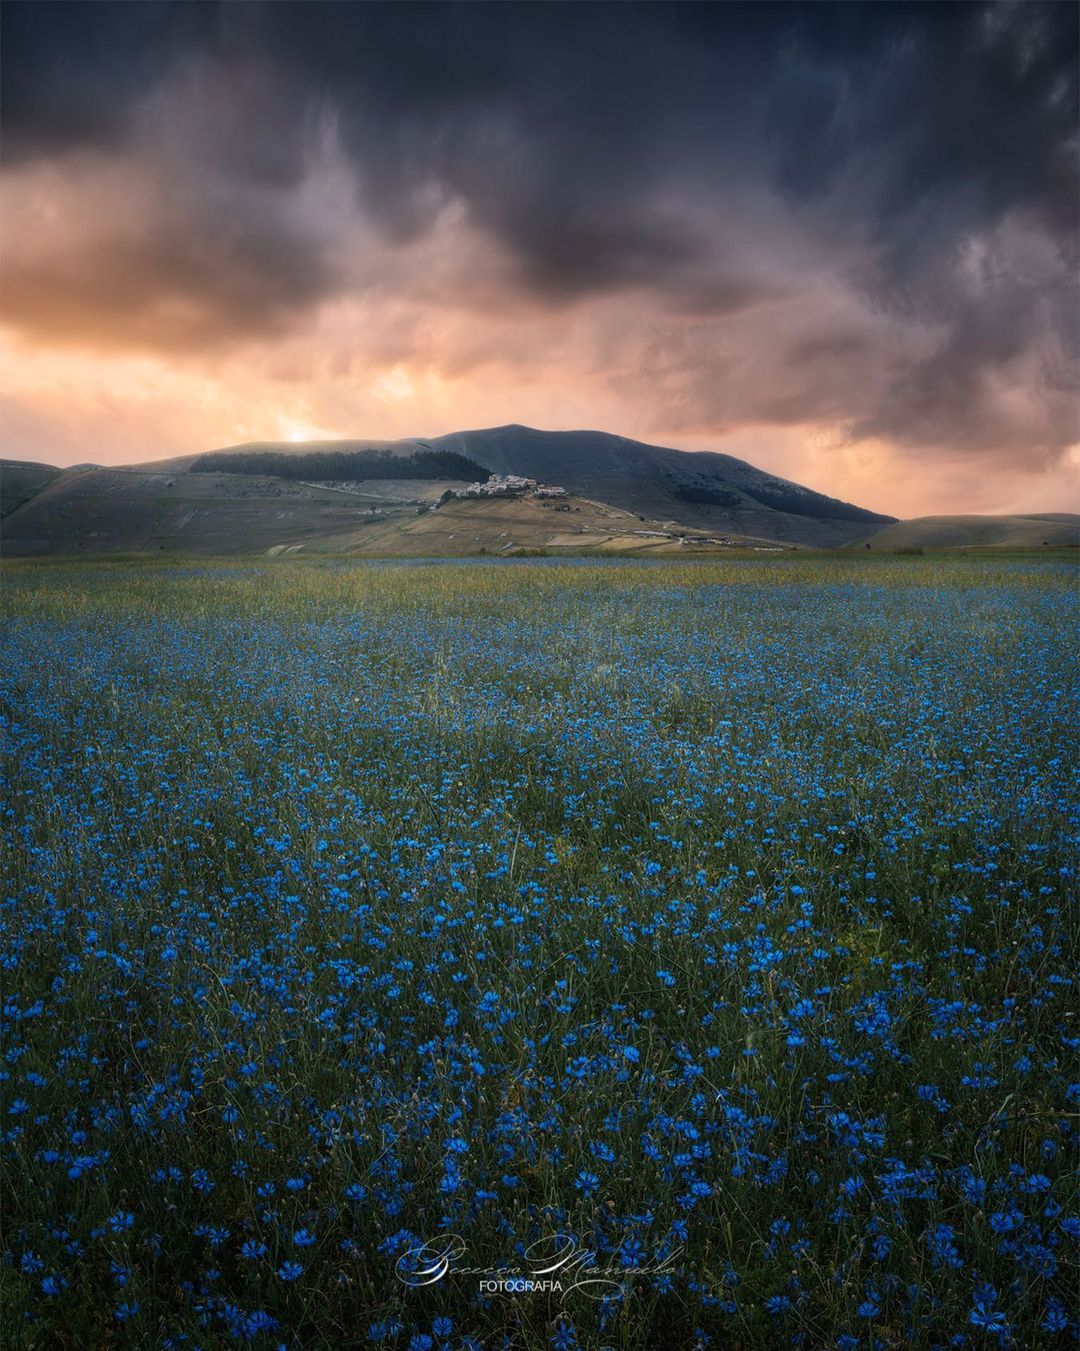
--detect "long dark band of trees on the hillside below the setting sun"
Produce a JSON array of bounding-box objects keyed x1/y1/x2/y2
[{"x1": 191, "y1": 450, "x2": 491, "y2": 484}]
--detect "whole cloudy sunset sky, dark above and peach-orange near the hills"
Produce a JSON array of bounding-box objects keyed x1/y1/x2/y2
[{"x1": 0, "y1": 0, "x2": 1080, "y2": 516}]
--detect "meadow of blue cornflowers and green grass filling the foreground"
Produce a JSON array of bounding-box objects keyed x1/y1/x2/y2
[{"x1": 0, "y1": 558, "x2": 1080, "y2": 1351}]
